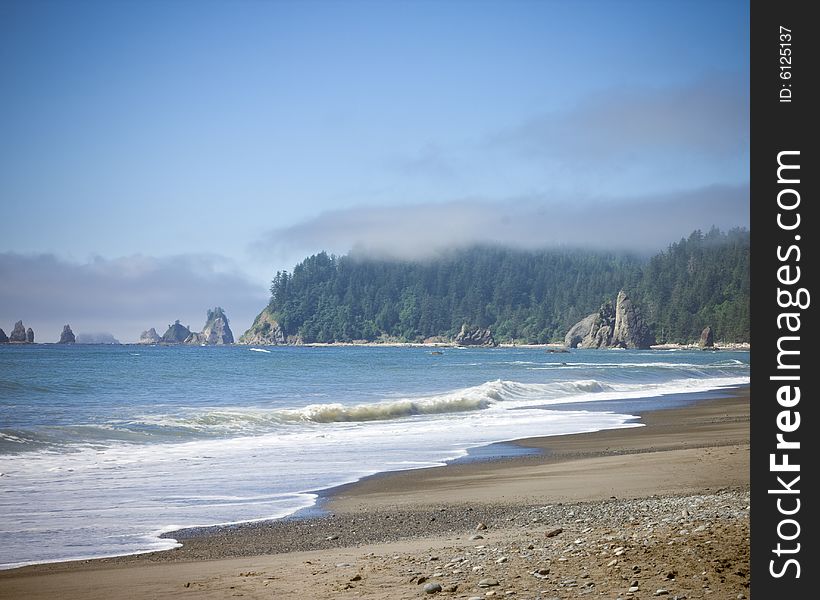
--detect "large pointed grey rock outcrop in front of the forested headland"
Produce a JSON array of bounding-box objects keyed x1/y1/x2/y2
[{"x1": 564, "y1": 290, "x2": 655, "y2": 348}]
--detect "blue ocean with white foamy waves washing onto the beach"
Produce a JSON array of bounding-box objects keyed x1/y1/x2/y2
[{"x1": 0, "y1": 345, "x2": 750, "y2": 568}]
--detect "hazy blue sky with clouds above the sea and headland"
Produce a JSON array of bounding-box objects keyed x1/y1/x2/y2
[{"x1": 0, "y1": 0, "x2": 749, "y2": 341}]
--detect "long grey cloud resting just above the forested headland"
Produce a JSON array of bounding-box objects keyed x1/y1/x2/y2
[{"x1": 252, "y1": 186, "x2": 749, "y2": 260}]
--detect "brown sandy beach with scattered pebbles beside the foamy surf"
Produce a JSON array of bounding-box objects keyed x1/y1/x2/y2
[{"x1": 0, "y1": 389, "x2": 749, "y2": 600}]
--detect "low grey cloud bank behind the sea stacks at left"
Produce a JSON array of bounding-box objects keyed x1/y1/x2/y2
[{"x1": 0, "y1": 252, "x2": 268, "y2": 342}]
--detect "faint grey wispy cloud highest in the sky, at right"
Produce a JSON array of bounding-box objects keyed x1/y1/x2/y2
[{"x1": 488, "y1": 76, "x2": 749, "y2": 163}]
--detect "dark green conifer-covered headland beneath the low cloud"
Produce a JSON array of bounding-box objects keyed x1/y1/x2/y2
[{"x1": 246, "y1": 229, "x2": 750, "y2": 343}]
